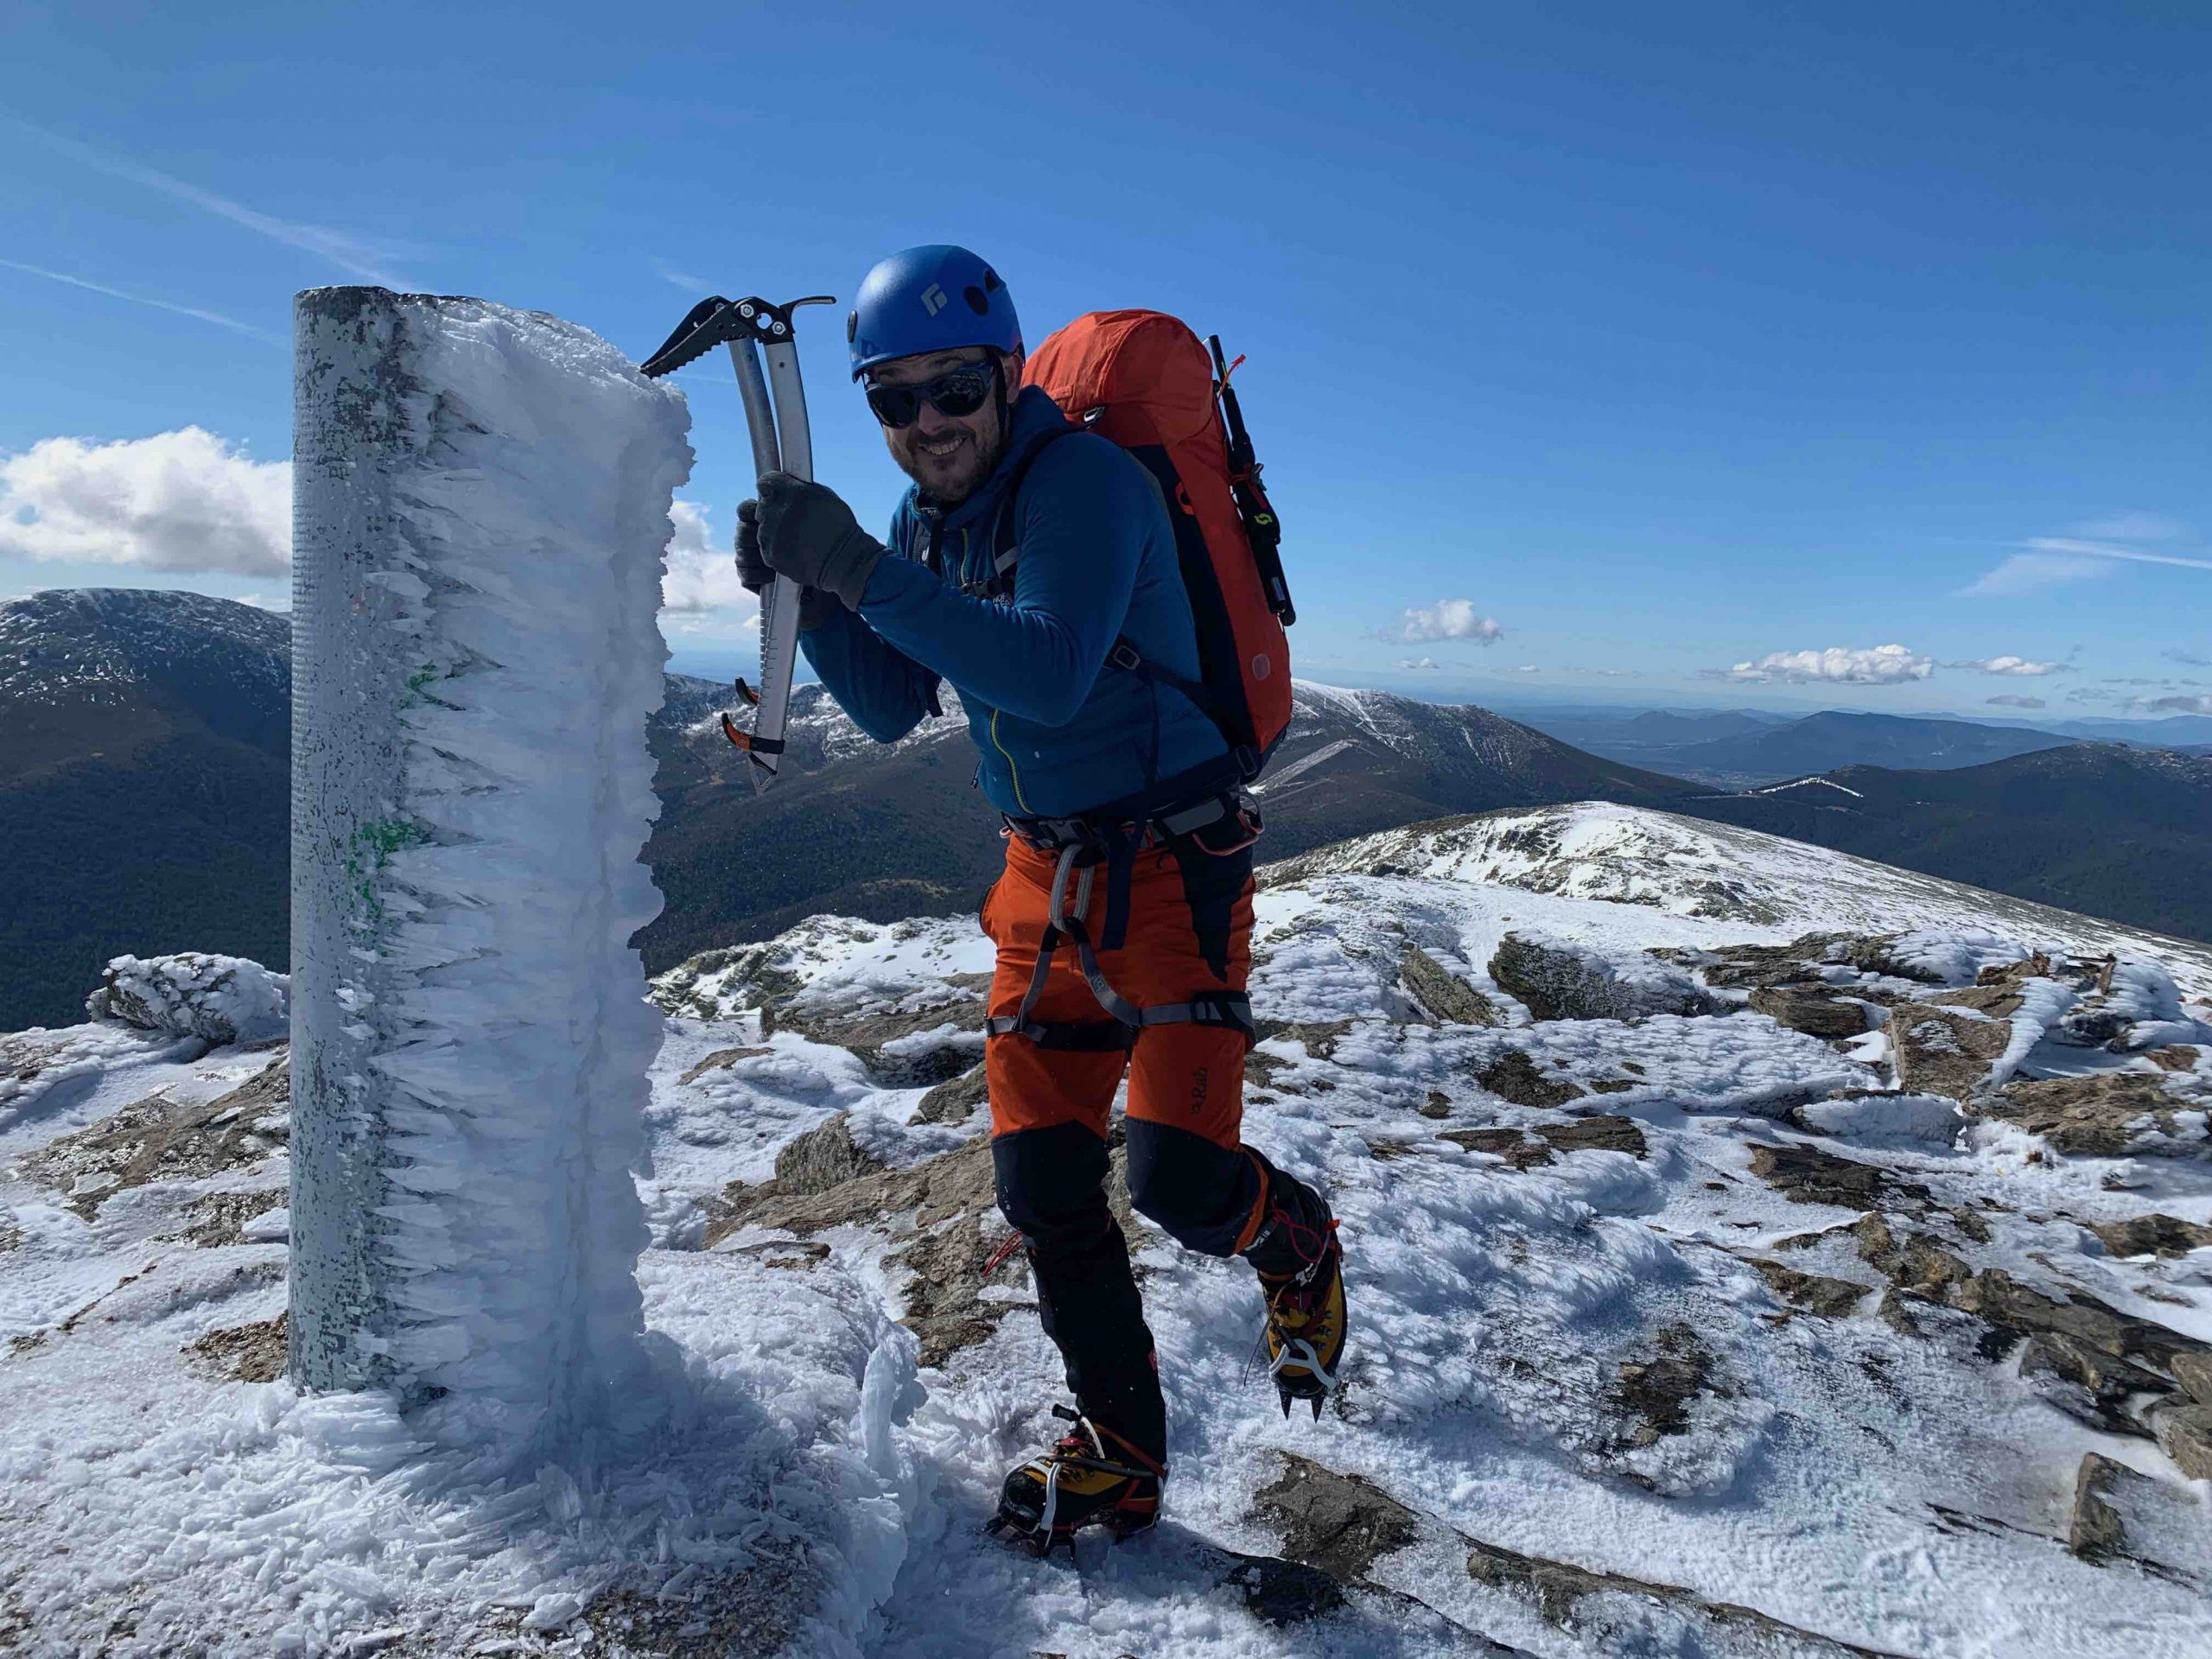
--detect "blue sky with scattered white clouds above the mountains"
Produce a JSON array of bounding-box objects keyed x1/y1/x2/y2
[{"x1": 0, "y1": 0, "x2": 2212, "y2": 719}]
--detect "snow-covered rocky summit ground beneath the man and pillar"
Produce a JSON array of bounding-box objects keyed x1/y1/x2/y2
[{"x1": 0, "y1": 807, "x2": 2212, "y2": 1659}]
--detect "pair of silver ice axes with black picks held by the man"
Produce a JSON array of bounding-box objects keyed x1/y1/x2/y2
[{"x1": 639, "y1": 294, "x2": 836, "y2": 794}]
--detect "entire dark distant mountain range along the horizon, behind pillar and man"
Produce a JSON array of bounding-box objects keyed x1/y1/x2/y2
[{"x1": 0, "y1": 588, "x2": 2212, "y2": 1028}]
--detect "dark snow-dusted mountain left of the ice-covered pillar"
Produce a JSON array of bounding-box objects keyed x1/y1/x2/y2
[{"x1": 0, "y1": 588, "x2": 292, "y2": 1027}]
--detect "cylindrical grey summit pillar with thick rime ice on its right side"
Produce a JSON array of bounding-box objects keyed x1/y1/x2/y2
[{"x1": 289, "y1": 288, "x2": 692, "y2": 1440}]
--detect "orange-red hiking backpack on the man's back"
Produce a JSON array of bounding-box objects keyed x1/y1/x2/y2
[{"x1": 1007, "y1": 312, "x2": 1299, "y2": 783}]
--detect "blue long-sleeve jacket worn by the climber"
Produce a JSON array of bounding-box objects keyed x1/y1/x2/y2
[{"x1": 801, "y1": 387, "x2": 1228, "y2": 818}]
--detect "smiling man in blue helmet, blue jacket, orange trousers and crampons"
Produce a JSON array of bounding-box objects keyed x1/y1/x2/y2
[{"x1": 739, "y1": 245, "x2": 1344, "y2": 1551}]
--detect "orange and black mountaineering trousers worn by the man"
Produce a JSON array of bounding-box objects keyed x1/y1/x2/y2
[{"x1": 982, "y1": 836, "x2": 1269, "y2": 1460}]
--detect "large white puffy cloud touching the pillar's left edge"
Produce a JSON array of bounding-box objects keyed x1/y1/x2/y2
[{"x1": 0, "y1": 427, "x2": 292, "y2": 575}]
